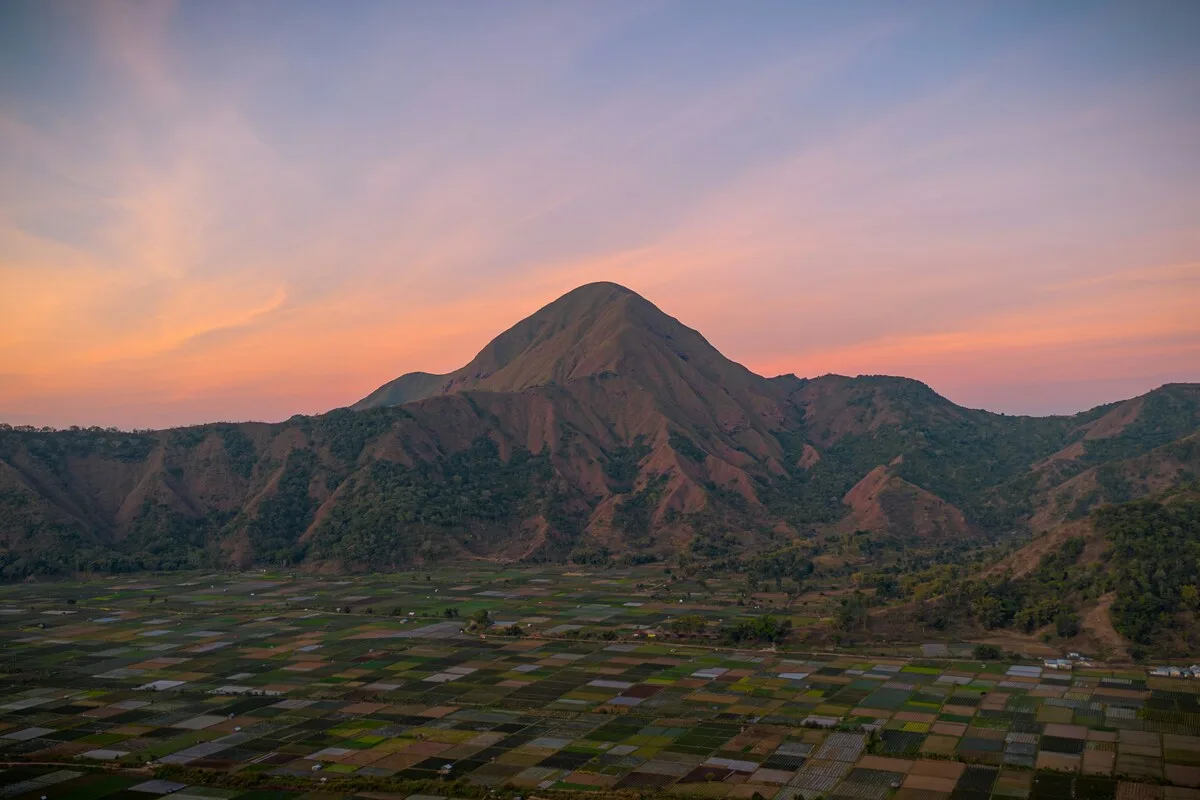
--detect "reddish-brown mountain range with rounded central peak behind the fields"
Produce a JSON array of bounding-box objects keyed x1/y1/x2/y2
[{"x1": 0, "y1": 283, "x2": 1200, "y2": 577}]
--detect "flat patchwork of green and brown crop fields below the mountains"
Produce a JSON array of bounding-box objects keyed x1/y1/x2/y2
[{"x1": 0, "y1": 566, "x2": 1200, "y2": 800}]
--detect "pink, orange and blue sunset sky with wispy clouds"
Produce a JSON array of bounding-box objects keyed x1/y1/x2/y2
[{"x1": 0, "y1": 0, "x2": 1200, "y2": 428}]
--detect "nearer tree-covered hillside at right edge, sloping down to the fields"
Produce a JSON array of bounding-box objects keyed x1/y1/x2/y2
[{"x1": 880, "y1": 487, "x2": 1200, "y2": 658}]
